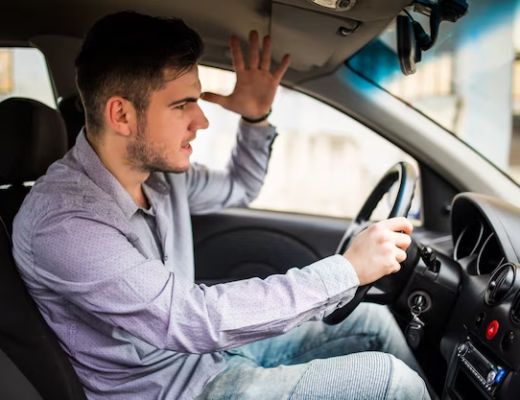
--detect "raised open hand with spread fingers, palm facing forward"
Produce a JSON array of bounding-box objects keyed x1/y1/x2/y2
[{"x1": 201, "y1": 31, "x2": 290, "y2": 119}]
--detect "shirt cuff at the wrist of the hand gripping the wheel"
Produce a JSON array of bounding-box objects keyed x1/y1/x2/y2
[{"x1": 317, "y1": 254, "x2": 359, "y2": 308}]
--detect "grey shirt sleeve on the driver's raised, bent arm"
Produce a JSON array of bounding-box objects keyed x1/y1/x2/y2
[{"x1": 186, "y1": 122, "x2": 277, "y2": 214}]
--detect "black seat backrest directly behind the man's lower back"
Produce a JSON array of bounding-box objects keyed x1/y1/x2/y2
[{"x1": 0, "y1": 219, "x2": 86, "y2": 400}]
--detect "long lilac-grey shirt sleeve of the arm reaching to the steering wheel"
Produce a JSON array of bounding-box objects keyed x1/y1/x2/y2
[{"x1": 32, "y1": 216, "x2": 359, "y2": 353}]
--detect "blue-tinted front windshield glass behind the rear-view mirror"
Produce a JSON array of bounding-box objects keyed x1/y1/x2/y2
[{"x1": 348, "y1": 0, "x2": 520, "y2": 183}]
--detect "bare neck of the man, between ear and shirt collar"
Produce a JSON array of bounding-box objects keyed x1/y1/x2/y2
[{"x1": 87, "y1": 133, "x2": 150, "y2": 208}]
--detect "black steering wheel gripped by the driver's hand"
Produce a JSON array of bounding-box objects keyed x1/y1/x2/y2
[{"x1": 323, "y1": 161, "x2": 419, "y2": 325}]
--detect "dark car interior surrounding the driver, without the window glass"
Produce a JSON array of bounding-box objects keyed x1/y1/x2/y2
[{"x1": 0, "y1": 0, "x2": 520, "y2": 400}]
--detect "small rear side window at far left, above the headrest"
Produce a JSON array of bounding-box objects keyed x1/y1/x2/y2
[{"x1": 0, "y1": 47, "x2": 56, "y2": 108}]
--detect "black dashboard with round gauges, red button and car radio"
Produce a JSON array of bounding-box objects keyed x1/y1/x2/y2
[{"x1": 401, "y1": 193, "x2": 520, "y2": 400}]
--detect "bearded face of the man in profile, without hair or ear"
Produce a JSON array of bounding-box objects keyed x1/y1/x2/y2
[{"x1": 127, "y1": 66, "x2": 208, "y2": 173}]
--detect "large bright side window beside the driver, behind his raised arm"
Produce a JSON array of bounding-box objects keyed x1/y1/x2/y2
[{"x1": 196, "y1": 67, "x2": 420, "y2": 219}]
